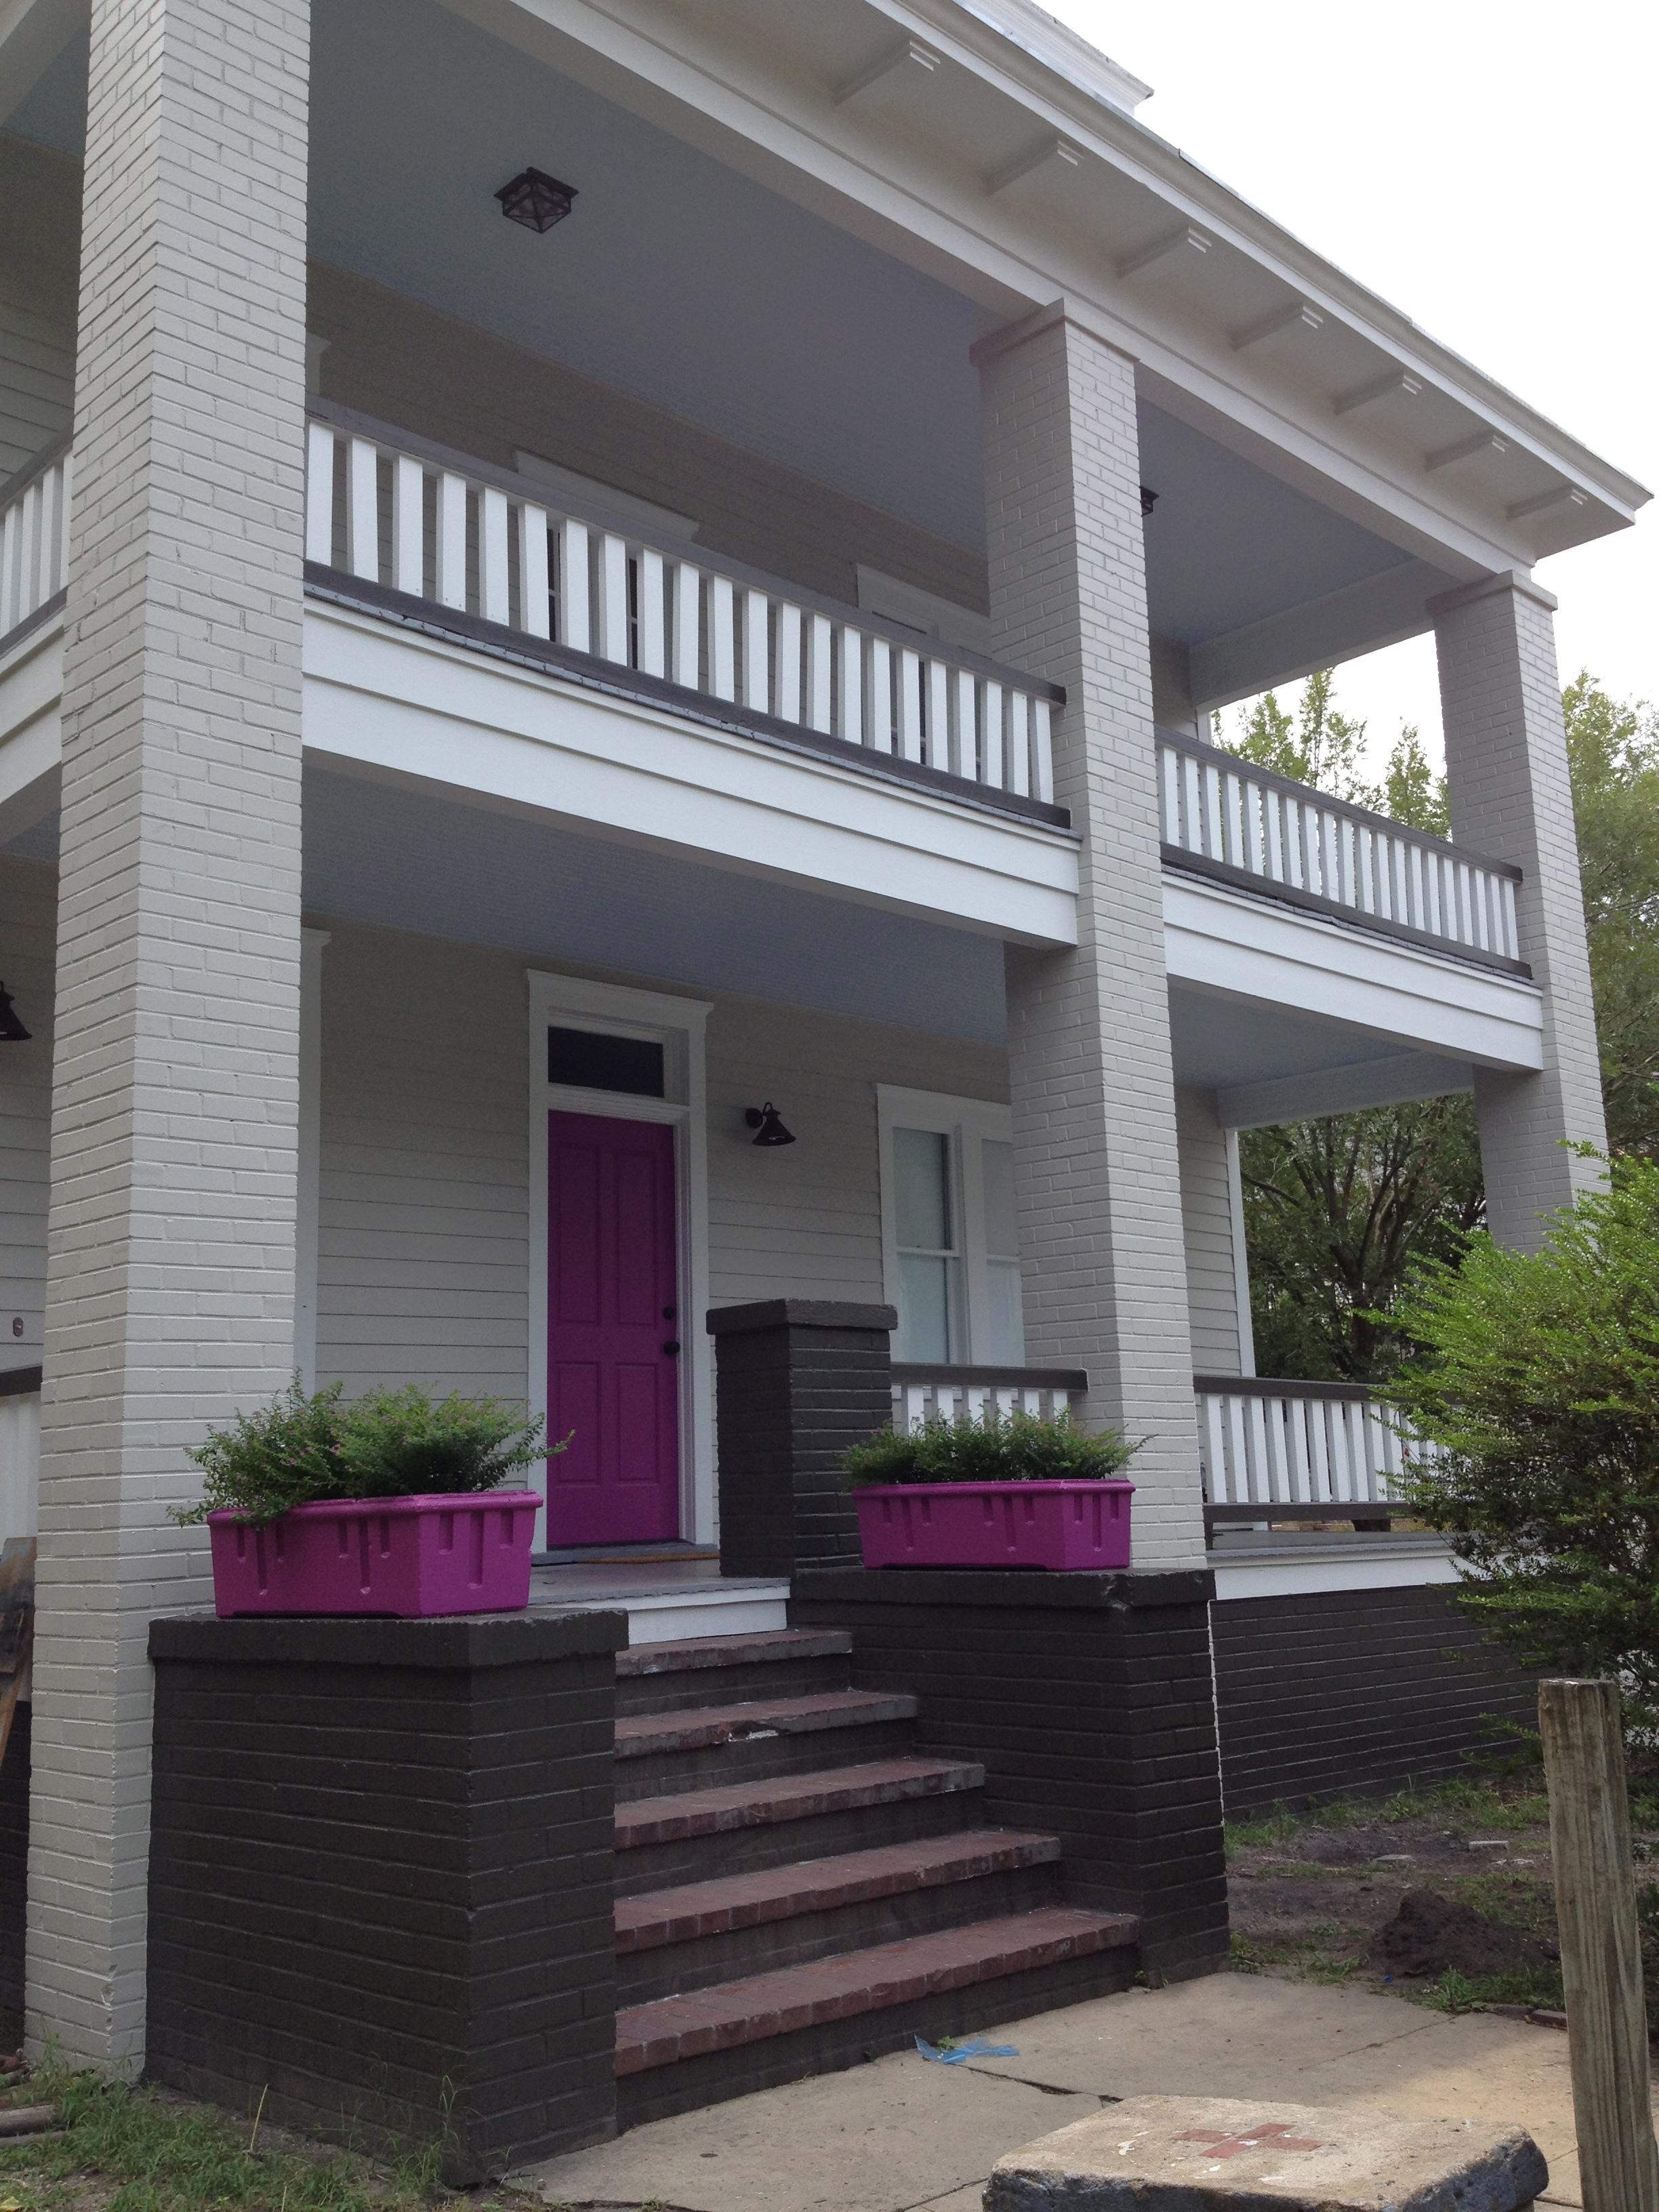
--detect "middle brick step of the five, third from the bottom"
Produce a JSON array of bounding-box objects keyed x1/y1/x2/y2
[{"x1": 615, "y1": 1759, "x2": 984, "y2": 1896}]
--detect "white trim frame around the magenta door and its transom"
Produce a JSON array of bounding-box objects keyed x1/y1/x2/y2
[{"x1": 525, "y1": 969, "x2": 714, "y2": 1551}]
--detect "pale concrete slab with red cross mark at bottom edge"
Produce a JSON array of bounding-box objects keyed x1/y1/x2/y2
[{"x1": 984, "y1": 2097, "x2": 1544, "y2": 2212}]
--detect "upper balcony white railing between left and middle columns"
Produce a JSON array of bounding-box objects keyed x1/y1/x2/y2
[{"x1": 305, "y1": 409, "x2": 1057, "y2": 803}]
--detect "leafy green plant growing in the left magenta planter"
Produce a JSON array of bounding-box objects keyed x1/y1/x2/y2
[{"x1": 175, "y1": 1380, "x2": 571, "y2": 1524}]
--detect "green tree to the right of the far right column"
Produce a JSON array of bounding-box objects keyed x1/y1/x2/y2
[{"x1": 1561, "y1": 670, "x2": 1659, "y2": 1159}]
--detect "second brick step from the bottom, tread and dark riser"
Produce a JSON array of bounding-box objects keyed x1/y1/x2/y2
[{"x1": 615, "y1": 1829, "x2": 1059, "y2": 2006}]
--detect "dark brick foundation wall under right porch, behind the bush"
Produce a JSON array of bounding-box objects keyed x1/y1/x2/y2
[{"x1": 1212, "y1": 1584, "x2": 1537, "y2": 1816}]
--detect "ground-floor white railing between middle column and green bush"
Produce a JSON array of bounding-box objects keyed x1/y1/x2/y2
[{"x1": 1195, "y1": 1376, "x2": 1433, "y2": 1519}]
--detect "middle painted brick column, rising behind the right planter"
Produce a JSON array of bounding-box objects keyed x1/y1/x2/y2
[{"x1": 973, "y1": 308, "x2": 1204, "y2": 1568}]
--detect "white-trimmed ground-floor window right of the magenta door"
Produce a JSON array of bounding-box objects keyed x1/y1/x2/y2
[{"x1": 876, "y1": 1084, "x2": 1024, "y2": 1367}]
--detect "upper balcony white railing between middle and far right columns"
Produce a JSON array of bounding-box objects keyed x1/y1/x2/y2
[{"x1": 1157, "y1": 732, "x2": 1519, "y2": 964}]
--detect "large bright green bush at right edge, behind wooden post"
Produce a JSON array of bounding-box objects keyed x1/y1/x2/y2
[{"x1": 1389, "y1": 1157, "x2": 1659, "y2": 1729}]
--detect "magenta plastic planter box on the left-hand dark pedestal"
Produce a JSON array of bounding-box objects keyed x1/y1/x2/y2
[{"x1": 208, "y1": 1491, "x2": 542, "y2": 1619}]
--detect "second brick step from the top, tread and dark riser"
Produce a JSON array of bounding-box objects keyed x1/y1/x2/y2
[{"x1": 617, "y1": 1690, "x2": 916, "y2": 1801}]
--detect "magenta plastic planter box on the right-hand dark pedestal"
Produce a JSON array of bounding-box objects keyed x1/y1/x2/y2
[{"x1": 854, "y1": 1480, "x2": 1134, "y2": 1573}]
